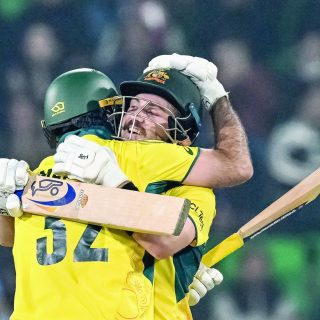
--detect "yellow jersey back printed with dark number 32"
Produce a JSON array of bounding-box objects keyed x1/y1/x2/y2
[{"x1": 11, "y1": 158, "x2": 149, "y2": 320}]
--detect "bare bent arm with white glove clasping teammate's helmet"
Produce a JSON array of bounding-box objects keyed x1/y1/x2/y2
[{"x1": 144, "y1": 54, "x2": 253, "y2": 187}]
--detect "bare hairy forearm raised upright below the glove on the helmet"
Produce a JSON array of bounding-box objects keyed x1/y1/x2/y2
[{"x1": 211, "y1": 97, "x2": 253, "y2": 184}]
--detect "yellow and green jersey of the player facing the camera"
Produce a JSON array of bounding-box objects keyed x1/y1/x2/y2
[{"x1": 154, "y1": 186, "x2": 215, "y2": 320}]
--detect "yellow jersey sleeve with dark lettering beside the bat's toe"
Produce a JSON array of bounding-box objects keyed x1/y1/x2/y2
[{"x1": 166, "y1": 186, "x2": 216, "y2": 246}]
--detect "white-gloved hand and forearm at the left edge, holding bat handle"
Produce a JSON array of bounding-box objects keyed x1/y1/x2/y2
[{"x1": 0, "y1": 158, "x2": 29, "y2": 247}]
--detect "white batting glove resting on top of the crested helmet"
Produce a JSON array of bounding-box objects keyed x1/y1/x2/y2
[{"x1": 144, "y1": 53, "x2": 228, "y2": 111}]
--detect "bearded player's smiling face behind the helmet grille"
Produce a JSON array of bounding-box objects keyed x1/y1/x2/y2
[{"x1": 121, "y1": 93, "x2": 177, "y2": 141}]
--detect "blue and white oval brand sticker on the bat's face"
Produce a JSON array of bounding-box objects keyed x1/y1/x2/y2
[{"x1": 29, "y1": 179, "x2": 76, "y2": 207}]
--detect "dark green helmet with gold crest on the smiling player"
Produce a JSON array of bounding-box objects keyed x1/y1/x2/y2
[{"x1": 115, "y1": 68, "x2": 201, "y2": 145}]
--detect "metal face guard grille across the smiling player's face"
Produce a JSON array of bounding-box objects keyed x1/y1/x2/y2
[{"x1": 105, "y1": 96, "x2": 198, "y2": 145}]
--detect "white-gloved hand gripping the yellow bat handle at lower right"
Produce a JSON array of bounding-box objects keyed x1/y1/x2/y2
[{"x1": 189, "y1": 263, "x2": 223, "y2": 306}]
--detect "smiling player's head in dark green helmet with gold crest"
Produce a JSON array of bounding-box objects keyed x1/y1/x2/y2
[{"x1": 109, "y1": 68, "x2": 201, "y2": 145}]
